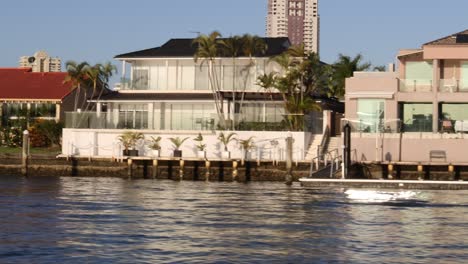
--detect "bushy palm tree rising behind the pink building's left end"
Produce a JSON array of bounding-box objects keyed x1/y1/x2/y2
[{"x1": 333, "y1": 54, "x2": 371, "y2": 98}]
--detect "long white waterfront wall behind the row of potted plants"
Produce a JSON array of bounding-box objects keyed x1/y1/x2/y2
[{"x1": 62, "y1": 128, "x2": 310, "y2": 161}]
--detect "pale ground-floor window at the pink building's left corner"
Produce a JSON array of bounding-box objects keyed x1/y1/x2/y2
[{"x1": 357, "y1": 99, "x2": 385, "y2": 133}]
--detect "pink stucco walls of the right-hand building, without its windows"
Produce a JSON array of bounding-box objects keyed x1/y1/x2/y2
[{"x1": 345, "y1": 36, "x2": 468, "y2": 163}]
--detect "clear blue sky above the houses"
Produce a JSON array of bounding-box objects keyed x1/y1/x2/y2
[{"x1": 0, "y1": 0, "x2": 468, "y2": 82}]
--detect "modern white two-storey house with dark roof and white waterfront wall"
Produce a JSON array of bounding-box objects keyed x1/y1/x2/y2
[{"x1": 62, "y1": 37, "x2": 330, "y2": 160}]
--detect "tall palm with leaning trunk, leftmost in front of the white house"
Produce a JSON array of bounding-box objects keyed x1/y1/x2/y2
[{"x1": 193, "y1": 31, "x2": 225, "y2": 127}]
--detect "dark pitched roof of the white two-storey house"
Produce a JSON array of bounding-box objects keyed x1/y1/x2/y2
[{"x1": 114, "y1": 37, "x2": 291, "y2": 59}]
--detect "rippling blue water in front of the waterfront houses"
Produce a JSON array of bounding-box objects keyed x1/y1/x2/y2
[{"x1": 0, "y1": 176, "x2": 468, "y2": 263}]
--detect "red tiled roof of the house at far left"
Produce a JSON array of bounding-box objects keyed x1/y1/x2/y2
[{"x1": 0, "y1": 68, "x2": 71, "y2": 100}]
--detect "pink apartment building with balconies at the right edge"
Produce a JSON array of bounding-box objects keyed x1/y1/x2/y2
[{"x1": 344, "y1": 30, "x2": 468, "y2": 164}]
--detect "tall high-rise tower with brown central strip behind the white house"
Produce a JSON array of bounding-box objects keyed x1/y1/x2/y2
[{"x1": 266, "y1": 0, "x2": 320, "y2": 53}]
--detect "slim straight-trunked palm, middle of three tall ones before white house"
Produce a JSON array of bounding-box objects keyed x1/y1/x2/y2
[{"x1": 219, "y1": 36, "x2": 244, "y2": 129}]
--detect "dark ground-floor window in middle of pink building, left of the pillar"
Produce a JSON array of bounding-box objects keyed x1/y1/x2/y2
[{"x1": 400, "y1": 103, "x2": 433, "y2": 132}]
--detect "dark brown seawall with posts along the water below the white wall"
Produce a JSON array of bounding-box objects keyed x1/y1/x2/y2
[{"x1": 0, "y1": 154, "x2": 310, "y2": 181}]
